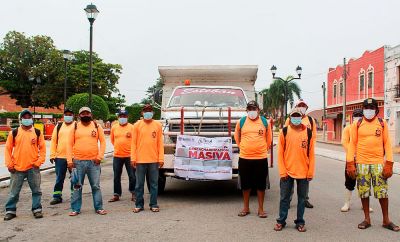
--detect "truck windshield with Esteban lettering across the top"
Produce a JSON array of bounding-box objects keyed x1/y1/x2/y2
[{"x1": 169, "y1": 87, "x2": 246, "y2": 107}]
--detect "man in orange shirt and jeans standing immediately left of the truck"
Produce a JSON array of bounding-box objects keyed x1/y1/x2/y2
[{"x1": 131, "y1": 104, "x2": 164, "y2": 213}]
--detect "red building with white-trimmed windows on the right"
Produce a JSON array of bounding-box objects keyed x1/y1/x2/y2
[{"x1": 326, "y1": 46, "x2": 388, "y2": 141}]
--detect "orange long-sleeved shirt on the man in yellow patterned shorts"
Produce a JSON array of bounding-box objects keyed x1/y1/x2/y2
[{"x1": 347, "y1": 118, "x2": 393, "y2": 164}]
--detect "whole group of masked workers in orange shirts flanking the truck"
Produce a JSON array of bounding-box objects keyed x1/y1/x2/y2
[{"x1": 4, "y1": 98, "x2": 400, "y2": 232}]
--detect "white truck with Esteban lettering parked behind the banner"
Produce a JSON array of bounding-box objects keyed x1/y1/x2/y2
[{"x1": 158, "y1": 65, "x2": 258, "y2": 193}]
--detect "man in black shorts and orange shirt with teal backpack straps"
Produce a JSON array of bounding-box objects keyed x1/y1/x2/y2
[{"x1": 235, "y1": 101, "x2": 272, "y2": 218}]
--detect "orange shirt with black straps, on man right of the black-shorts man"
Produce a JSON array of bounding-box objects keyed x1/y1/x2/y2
[{"x1": 278, "y1": 125, "x2": 315, "y2": 179}]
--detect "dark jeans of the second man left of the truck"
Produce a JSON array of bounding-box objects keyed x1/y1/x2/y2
[{"x1": 113, "y1": 157, "x2": 136, "y2": 196}]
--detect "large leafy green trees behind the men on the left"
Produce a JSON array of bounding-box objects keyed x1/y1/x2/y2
[{"x1": 0, "y1": 31, "x2": 122, "y2": 108}]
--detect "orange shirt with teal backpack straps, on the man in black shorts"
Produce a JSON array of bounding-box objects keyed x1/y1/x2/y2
[{"x1": 235, "y1": 117, "x2": 272, "y2": 159}]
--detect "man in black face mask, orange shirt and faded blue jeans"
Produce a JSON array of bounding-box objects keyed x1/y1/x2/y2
[{"x1": 67, "y1": 107, "x2": 107, "y2": 216}]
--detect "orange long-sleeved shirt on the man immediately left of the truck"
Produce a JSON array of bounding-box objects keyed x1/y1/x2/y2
[{"x1": 131, "y1": 120, "x2": 164, "y2": 163}]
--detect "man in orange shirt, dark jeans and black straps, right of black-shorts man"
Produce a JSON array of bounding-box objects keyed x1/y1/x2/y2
[{"x1": 274, "y1": 108, "x2": 315, "y2": 232}]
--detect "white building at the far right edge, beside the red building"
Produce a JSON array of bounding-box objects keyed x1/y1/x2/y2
[{"x1": 384, "y1": 45, "x2": 400, "y2": 146}]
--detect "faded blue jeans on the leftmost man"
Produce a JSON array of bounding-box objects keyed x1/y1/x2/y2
[{"x1": 6, "y1": 168, "x2": 42, "y2": 214}]
